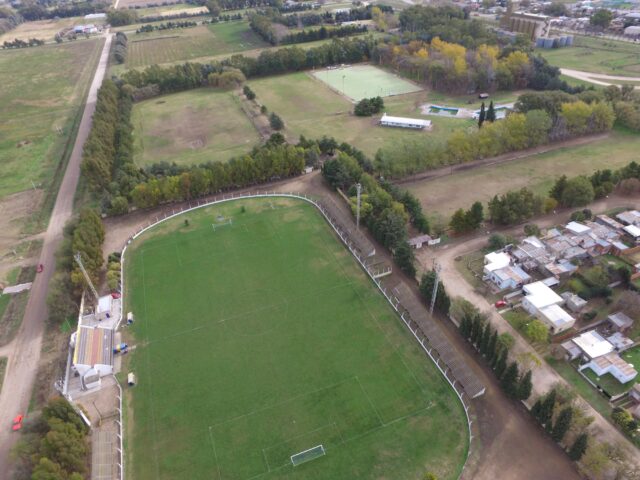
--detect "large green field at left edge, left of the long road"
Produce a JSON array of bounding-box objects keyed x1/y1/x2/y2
[{"x1": 0, "y1": 39, "x2": 104, "y2": 198}]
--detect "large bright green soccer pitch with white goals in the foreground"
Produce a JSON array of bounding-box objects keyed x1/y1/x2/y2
[{"x1": 125, "y1": 199, "x2": 468, "y2": 480}]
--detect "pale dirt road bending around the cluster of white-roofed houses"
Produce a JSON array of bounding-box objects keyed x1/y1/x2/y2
[{"x1": 418, "y1": 196, "x2": 640, "y2": 470}]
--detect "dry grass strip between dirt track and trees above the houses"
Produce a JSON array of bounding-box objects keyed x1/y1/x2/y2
[{"x1": 405, "y1": 131, "x2": 640, "y2": 221}]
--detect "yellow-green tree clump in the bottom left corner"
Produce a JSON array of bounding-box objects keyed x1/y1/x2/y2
[{"x1": 13, "y1": 397, "x2": 90, "y2": 480}]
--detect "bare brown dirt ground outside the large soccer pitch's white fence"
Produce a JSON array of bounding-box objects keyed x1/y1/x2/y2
[{"x1": 104, "y1": 172, "x2": 580, "y2": 480}]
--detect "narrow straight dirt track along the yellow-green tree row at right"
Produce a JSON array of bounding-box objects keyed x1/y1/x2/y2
[{"x1": 394, "y1": 133, "x2": 610, "y2": 186}]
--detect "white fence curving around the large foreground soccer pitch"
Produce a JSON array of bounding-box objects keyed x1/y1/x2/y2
[{"x1": 115, "y1": 191, "x2": 473, "y2": 480}]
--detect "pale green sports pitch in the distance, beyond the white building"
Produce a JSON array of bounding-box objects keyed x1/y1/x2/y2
[{"x1": 313, "y1": 65, "x2": 422, "y2": 102}]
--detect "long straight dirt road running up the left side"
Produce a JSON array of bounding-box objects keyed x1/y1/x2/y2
[{"x1": 0, "y1": 32, "x2": 111, "y2": 470}]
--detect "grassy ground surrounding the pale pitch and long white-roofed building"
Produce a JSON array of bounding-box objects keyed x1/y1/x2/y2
[{"x1": 249, "y1": 72, "x2": 475, "y2": 156}]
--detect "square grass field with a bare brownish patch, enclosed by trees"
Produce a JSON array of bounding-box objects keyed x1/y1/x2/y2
[{"x1": 132, "y1": 88, "x2": 260, "y2": 166}]
